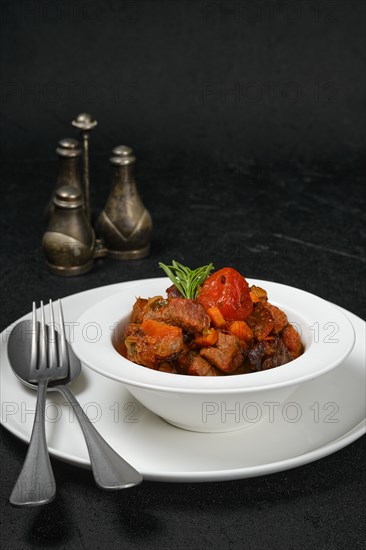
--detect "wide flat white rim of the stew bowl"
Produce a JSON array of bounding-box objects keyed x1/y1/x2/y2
[{"x1": 73, "y1": 277, "x2": 355, "y2": 394}]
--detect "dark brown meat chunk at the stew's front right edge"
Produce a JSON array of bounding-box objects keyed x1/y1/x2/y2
[{"x1": 247, "y1": 336, "x2": 292, "y2": 371}]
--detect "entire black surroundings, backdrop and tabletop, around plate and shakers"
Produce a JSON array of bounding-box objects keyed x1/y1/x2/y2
[{"x1": 0, "y1": 0, "x2": 366, "y2": 550}]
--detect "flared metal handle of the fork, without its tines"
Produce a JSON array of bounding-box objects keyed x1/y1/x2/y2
[{"x1": 9, "y1": 380, "x2": 56, "y2": 506}]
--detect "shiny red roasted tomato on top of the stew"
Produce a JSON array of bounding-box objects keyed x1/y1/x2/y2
[{"x1": 197, "y1": 267, "x2": 253, "y2": 321}]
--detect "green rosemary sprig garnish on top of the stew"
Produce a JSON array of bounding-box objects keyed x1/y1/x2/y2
[{"x1": 159, "y1": 260, "x2": 214, "y2": 300}]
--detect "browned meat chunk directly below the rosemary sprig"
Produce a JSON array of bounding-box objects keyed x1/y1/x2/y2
[{"x1": 144, "y1": 298, "x2": 210, "y2": 333}]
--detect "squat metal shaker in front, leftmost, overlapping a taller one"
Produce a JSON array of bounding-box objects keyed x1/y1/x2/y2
[{"x1": 42, "y1": 185, "x2": 95, "y2": 277}]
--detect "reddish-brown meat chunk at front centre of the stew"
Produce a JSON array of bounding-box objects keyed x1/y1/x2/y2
[{"x1": 200, "y1": 332, "x2": 243, "y2": 374}]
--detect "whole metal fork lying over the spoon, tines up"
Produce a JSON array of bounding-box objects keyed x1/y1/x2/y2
[{"x1": 10, "y1": 300, "x2": 69, "y2": 506}]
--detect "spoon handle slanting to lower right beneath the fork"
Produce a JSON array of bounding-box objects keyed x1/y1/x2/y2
[{"x1": 56, "y1": 385, "x2": 142, "y2": 490}]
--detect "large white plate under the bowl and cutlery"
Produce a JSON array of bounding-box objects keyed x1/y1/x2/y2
[{"x1": 0, "y1": 283, "x2": 366, "y2": 481}]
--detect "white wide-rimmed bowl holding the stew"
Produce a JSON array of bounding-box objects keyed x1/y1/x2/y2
[{"x1": 73, "y1": 277, "x2": 355, "y2": 432}]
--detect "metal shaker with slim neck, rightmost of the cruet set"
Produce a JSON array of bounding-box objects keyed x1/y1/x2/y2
[{"x1": 97, "y1": 145, "x2": 152, "y2": 260}]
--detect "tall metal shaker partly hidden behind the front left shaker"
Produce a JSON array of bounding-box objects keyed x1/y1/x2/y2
[{"x1": 46, "y1": 138, "x2": 84, "y2": 220}]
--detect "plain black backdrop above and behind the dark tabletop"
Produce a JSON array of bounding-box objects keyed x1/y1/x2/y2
[{"x1": 0, "y1": 0, "x2": 365, "y2": 170}]
